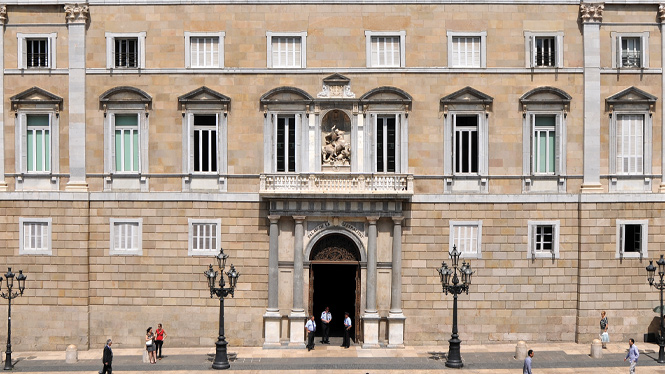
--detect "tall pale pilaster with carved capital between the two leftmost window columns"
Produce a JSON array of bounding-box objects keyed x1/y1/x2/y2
[{"x1": 65, "y1": 4, "x2": 88, "y2": 192}]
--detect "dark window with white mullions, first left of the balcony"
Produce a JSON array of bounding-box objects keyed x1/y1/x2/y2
[{"x1": 194, "y1": 115, "x2": 217, "y2": 173}]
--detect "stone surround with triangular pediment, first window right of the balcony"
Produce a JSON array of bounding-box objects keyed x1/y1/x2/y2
[{"x1": 440, "y1": 86, "x2": 494, "y2": 193}]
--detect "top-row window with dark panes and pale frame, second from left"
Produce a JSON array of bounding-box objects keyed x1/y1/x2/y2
[{"x1": 106, "y1": 32, "x2": 146, "y2": 69}]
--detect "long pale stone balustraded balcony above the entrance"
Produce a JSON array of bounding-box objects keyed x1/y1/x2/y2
[{"x1": 259, "y1": 173, "x2": 413, "y2": 199}]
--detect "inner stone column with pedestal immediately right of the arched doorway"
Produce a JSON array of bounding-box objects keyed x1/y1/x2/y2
[{"x1": 363, "y1": 217, "x2": 379, "y2": 348}]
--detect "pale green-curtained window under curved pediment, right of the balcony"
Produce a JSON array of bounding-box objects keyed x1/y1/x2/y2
[{"x1": 531, "y1": 114, "x2": 556, "y2": 174}]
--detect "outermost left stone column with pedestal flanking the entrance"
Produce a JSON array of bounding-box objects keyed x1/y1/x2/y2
[{"x1": 263, "y1": 215, "x2": 281, "y2": 348}]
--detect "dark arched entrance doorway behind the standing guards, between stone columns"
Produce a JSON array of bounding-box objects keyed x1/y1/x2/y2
[{"x1": 308, "y1": 233, "x2": 362, "y2": 342}]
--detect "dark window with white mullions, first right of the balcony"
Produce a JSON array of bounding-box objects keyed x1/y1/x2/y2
[{"x1": 453, "y1": 115, "x2": 479, "y2": 174}]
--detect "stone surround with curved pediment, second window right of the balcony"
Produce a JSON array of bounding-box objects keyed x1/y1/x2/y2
[{"x1": 520, "y1": 86, "x2": 572, "y2": 193}]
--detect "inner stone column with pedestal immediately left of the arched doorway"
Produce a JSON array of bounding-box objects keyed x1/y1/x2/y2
[{"x1": 289, "y1": 216, "x2": 306, "y2": 348}]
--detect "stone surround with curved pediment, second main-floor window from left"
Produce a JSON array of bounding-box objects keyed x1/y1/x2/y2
[{"x1": 99, "y1": 86, "x2": 152, "y2": 192}]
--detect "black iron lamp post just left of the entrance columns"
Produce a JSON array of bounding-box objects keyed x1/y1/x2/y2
[{"x1": 203, "y1": 248, "x2": 240, "y2": 370}]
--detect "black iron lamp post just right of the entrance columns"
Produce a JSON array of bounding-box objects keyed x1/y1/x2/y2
[{"x1": 438, "y1": 246, "x2": 473, "y2": 368}]
